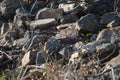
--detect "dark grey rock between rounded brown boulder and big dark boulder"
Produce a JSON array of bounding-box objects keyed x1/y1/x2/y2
[{"x1": 60, "y1": 14, "x2": 78, "y2": 24}]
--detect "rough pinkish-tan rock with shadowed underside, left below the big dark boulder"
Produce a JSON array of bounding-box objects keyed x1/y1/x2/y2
[{"x1": 55, "y1": 26, "x2": 79, "y2": 43}]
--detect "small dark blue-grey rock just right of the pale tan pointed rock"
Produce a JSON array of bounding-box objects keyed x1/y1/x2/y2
[{"x1": 35, "y1": 52, "x2": 46, "y2": 65}]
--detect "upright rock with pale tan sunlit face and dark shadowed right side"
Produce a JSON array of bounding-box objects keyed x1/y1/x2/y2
[{"x1": 22, "y1": 51, "x2": 36, "y2": 67}]
